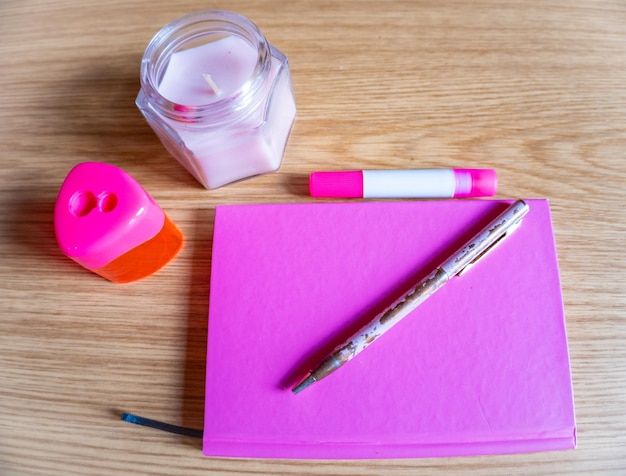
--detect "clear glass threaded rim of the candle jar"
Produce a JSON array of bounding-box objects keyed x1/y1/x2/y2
[{"x1": 140, "y1": 10, "x2": 271, "y2": 125}]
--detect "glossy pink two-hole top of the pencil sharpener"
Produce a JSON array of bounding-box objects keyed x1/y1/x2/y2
[{"x1": 54, "y1": 162, "x2": 166, "y2": 271}]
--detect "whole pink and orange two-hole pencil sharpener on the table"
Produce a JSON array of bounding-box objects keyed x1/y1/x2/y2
[{"x1": 54, "y1": 162, "x2": 182, "y2": 282}]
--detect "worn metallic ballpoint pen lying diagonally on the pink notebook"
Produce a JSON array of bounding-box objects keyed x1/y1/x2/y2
[{"x1": 292, "y1": 200, "x2": 529, "y2": 393}]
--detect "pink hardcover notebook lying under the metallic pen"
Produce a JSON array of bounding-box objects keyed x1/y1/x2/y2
[{"x1": 203, "y1": 200, "x2": 576, "y2": 459}]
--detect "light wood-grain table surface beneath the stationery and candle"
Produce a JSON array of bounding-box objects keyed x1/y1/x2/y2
[{"x1": 0, "y1": 0, "x2": 626, "y2": 476}]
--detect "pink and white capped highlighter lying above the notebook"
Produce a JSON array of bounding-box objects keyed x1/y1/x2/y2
[{"x1": 309, "y1": 169, "x2": 498, "y2": 198}]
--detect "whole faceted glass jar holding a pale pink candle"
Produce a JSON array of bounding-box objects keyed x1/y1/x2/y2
[{"x1": 136, "y1": 10, "x2": 296, "y2": 189}]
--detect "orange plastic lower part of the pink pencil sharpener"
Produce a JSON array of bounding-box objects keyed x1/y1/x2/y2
[{"x1": 92, "y1": 215, "x2": 183, "y2": 283}]
